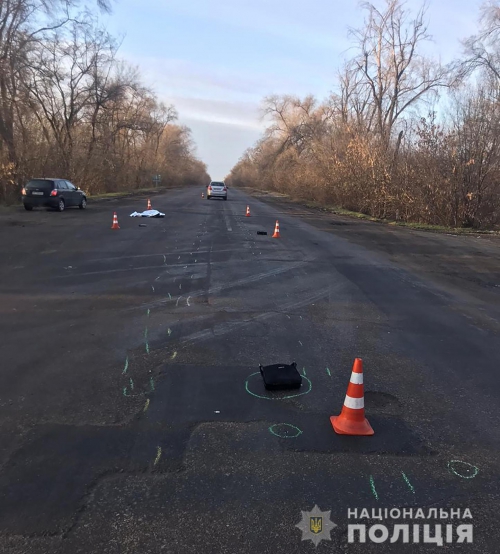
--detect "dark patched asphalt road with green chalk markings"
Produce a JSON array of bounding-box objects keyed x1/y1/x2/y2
[{"x1": 0, "y1": 187, "x2": 500, "y2": 554}]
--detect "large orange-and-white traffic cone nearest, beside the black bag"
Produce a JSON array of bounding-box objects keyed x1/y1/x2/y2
[{"x1": 330, "y1": 358, "x2": 375, "y2": 436}]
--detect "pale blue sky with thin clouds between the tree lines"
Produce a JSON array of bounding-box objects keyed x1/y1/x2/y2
[{"x1": 105, "y1": 0, "x2": 482, "y2": 180}]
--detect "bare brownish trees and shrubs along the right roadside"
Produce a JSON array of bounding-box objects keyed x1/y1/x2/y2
[{"x1": 227, "y1": 0, "x2": 500, "y2": 228}]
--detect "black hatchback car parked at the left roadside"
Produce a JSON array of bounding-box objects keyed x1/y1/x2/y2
[{"x1": 22, "y1": 179, "x2": 87, "y2": 212}]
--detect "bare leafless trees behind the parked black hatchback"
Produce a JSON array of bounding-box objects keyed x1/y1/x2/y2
[{"x1": 0, "y1": 0, "x2": 209, "y2": 202}]
